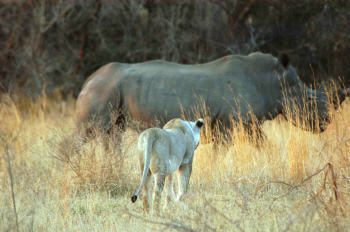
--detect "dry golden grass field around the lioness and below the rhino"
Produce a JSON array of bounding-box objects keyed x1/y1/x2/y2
[{"x1": 0, "y1": 95, "x2": 350, "y2": 231}]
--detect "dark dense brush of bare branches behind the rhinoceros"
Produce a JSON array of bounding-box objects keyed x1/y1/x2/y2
[{"x1": 0, "y1": 0, "x2": 350, "y2": 96}]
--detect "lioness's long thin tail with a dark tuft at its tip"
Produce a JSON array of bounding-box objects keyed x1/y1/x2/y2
[{"x1": 131, "y1": 130, "x2": 156, "y2": 203}]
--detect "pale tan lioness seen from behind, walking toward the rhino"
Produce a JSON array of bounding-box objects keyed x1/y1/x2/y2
[{"x1": 131, "y1": 118, "x2": 204, "y2": 214}]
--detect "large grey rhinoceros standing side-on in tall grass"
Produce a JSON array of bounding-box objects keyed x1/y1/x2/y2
[{"x1": 76, "y1": 52, "x2": 350, "y2": 140}]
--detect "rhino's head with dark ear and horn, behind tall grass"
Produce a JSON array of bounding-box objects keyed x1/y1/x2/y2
[{"x1": 276, "y1": 53, "x2": 350, "y2": 132}]
